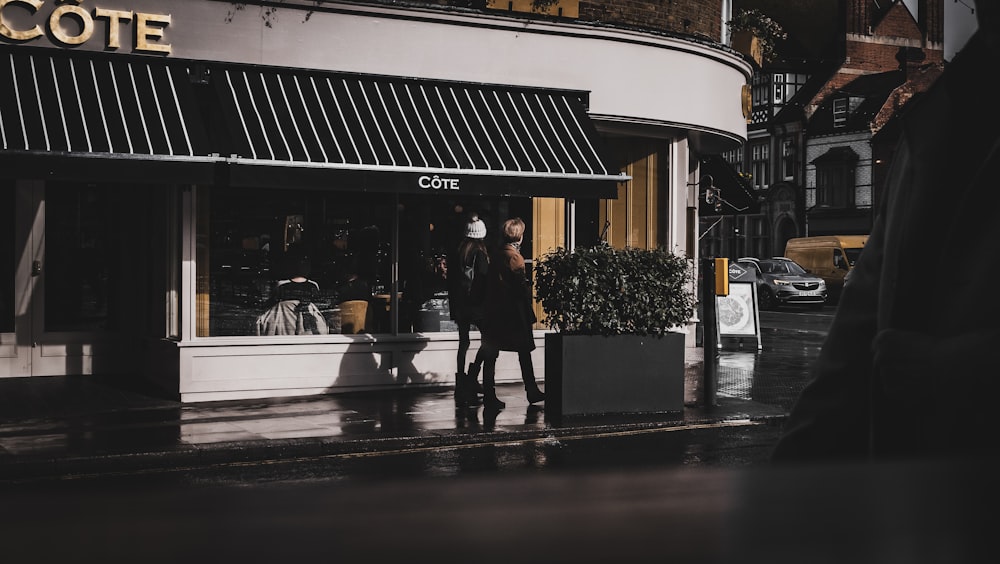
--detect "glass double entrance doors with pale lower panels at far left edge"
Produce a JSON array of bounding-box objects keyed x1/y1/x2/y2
[{"x1": 0, "y1": 181, "x2": 122, "y2": 376}]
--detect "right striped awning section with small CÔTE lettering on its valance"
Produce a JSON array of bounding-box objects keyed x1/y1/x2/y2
[{"x1": 212, "y1": 62, "x2": 627, "y2": 198}]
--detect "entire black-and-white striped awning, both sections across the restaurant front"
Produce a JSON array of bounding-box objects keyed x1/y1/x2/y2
[{"x1": 0, "y1": 46, "x2": 628, "y2": 198}]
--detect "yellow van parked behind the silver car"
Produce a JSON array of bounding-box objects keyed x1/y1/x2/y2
[{"x1": 784, "y1": 235, "x2": 868, "y2": 302}]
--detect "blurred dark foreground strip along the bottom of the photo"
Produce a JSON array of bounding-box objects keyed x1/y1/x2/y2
[{"x1": 0, "y1": 459, "x2": 997, "y2": 564}]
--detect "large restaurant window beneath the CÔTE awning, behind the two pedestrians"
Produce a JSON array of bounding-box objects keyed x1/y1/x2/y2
[{"x1": 197, "y1": 187, "x2": 531, "y2": 337}]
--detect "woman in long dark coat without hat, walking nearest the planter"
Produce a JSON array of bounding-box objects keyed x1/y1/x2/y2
[{"x1": 481, "y1": 218, "x2": 545, "y2": 409}]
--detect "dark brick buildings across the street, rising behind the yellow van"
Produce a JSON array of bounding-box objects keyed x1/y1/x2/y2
[{"x1": 702, "y1": 0, "x2": 944, "y2": 257}]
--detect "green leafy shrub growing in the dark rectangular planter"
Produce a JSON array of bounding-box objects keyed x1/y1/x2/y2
[{"x1": 534, "y1": 244, "x2": 695, "y2": 335}]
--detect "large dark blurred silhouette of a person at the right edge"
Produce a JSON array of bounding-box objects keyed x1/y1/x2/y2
[{"x1": 773, "y1": 0, "x2": 1000, "y2": 461}]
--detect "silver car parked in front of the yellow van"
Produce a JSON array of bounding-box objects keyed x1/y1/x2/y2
[{"x1": 737, "y1": 257, "x2": 827, "y2": 309}]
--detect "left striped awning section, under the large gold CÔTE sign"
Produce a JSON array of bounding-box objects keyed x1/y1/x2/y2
[{"x1": 0, "y1": 48, "x2": 219, "y2": 181}]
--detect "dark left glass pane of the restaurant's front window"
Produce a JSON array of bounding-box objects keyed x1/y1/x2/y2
[{"x1": 198, "y1": 188, "x2": 392, "y2": 336}]
